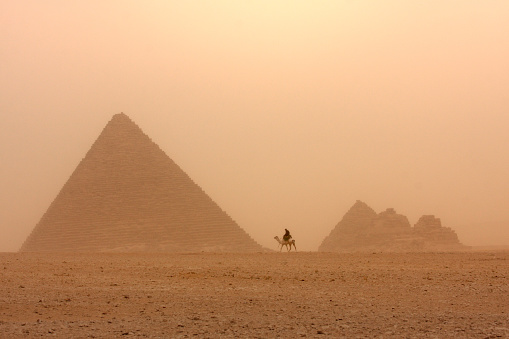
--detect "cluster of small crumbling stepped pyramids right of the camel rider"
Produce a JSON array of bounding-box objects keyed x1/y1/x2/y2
[{"x1": 318, "y1": 200, "x2": 468, "y2": 252}]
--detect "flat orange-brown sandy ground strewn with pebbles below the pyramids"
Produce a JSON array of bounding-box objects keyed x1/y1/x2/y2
[{"x1": 0, "y1": 252, "x2": 509, "y2": 338}]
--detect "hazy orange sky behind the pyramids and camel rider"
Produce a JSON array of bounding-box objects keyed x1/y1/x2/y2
[{"x1": 0, "y1": 0, "x2": 509, "y2": 251}]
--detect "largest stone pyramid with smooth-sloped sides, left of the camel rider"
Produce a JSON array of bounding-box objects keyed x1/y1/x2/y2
[{"x1": 20, "y1": 113, "x2": 263, "y2": 252}]
